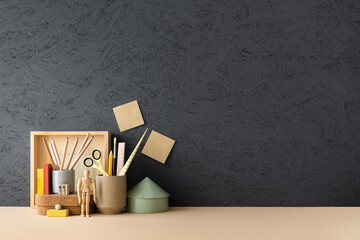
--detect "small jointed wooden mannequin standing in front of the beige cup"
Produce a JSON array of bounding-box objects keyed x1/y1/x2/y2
[{"x1": 77, "y1": 170, "x2": 96, "y2": 217}]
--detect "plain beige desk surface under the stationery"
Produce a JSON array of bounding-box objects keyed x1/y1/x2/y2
[{"x1": 0, "y1": 207, "x2": 360, "y2": 240}]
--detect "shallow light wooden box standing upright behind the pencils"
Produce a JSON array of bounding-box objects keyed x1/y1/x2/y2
[{"x1": 30, "y1": 131, "x2": 111, "y2": 208}]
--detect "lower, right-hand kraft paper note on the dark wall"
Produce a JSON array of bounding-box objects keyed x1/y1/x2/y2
[{"x1": 141, "y1": 130, "x2": 175, "y2": 163}]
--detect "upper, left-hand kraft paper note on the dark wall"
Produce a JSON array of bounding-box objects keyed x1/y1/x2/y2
[{"x1": 113, "y1": 100, "x2": 144, "y2": 132}]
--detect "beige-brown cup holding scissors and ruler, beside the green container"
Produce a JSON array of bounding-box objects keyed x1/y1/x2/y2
[{"x1": 96, "y1": 175, "x2": 126, "y2": 214}]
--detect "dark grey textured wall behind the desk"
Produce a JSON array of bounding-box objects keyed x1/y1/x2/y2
[{"x1": 0, "y1": 0, "x2": 360, "y2": 206}]
